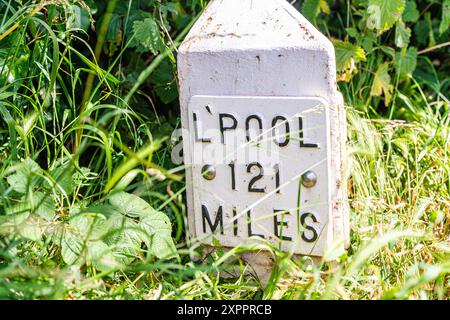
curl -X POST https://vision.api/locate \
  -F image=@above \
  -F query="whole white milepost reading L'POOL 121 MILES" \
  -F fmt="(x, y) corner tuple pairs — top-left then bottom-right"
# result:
(178, 0), (349, 266)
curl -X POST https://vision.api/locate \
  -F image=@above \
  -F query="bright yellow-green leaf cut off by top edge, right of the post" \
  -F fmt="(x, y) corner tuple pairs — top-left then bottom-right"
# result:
(367, 0), (405, 33)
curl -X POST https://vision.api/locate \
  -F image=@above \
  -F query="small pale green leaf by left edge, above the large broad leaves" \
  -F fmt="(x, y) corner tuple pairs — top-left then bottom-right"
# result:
(6, 158), (42, 194)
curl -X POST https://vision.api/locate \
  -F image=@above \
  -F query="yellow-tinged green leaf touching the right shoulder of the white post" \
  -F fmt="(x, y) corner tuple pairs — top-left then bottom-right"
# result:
(333, 40), (366, 82)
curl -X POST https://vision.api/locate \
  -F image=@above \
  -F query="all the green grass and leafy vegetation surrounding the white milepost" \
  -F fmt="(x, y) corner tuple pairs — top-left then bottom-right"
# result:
(0, 0), (450, 299)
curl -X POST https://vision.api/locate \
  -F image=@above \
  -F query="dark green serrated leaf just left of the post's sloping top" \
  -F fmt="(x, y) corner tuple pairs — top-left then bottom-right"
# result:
(133, 18), (163, 55)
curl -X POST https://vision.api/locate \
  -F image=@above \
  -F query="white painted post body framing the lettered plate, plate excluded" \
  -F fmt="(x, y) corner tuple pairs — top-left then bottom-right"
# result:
(178, 0), (349, 268)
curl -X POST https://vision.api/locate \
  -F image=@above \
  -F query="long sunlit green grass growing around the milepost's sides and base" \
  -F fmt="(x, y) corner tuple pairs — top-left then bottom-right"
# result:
(0, 0), (450, 299)
